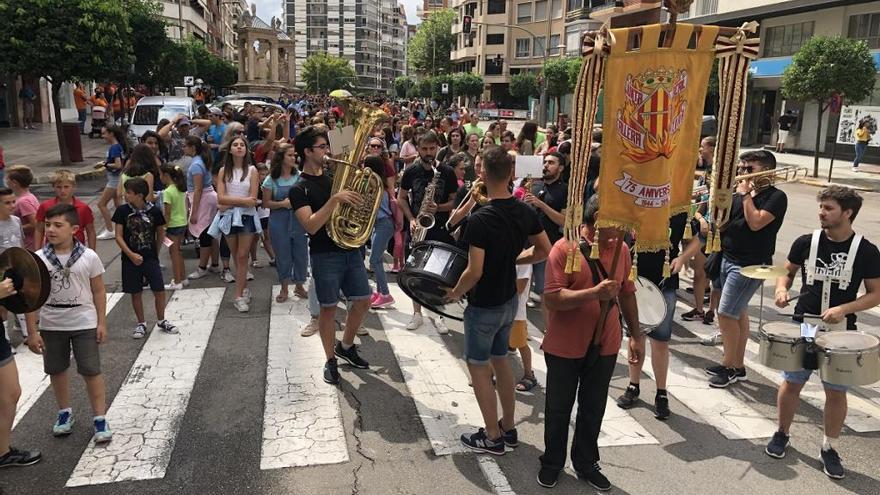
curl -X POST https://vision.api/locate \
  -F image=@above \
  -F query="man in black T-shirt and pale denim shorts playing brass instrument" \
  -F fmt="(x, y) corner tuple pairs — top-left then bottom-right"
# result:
(706, 150), (788, 388)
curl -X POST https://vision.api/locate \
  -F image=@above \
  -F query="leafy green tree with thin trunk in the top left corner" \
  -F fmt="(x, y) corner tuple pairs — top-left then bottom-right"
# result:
(0, 0), (134, 166)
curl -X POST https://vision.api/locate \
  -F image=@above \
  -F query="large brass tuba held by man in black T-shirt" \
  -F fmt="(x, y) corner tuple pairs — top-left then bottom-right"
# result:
(324, 98), (390, 249)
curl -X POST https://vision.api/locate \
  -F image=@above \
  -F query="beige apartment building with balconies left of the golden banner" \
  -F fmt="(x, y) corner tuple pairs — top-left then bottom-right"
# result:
(450, 0), (566, 109)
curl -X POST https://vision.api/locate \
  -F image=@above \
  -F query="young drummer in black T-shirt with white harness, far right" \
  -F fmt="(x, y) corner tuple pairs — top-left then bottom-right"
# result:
(764, 186), (880, 479)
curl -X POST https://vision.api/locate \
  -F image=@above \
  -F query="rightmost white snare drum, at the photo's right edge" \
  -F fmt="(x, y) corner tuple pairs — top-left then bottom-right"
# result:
(816, 331), (880, 386)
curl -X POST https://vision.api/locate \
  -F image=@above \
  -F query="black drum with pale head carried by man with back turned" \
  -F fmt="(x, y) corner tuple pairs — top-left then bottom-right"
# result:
(397, 241), (467, 321)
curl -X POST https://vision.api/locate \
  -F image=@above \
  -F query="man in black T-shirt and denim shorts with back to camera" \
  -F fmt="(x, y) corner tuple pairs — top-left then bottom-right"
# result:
(447, 146), (550, 455)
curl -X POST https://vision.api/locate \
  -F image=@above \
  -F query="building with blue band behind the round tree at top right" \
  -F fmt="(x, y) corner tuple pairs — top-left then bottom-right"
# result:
(688, 0), (880, 154)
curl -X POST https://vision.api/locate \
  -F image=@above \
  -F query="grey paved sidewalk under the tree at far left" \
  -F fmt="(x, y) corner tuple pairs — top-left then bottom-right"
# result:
(0, 122), (108, 184)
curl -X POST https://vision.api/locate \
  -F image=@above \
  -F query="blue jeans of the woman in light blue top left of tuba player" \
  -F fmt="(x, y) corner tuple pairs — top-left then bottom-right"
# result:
(269, 210), (309, 284)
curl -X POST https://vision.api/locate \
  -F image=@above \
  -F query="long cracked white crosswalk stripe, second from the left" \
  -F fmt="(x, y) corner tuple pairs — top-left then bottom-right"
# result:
(67, 288), (225, 487)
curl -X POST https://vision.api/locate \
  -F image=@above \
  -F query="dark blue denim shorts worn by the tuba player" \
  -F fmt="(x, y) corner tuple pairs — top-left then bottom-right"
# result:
(311, 249), (372, 307)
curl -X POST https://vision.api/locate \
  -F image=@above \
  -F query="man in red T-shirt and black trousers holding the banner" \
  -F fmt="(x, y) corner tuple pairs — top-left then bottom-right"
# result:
(538, 195), (639, 490)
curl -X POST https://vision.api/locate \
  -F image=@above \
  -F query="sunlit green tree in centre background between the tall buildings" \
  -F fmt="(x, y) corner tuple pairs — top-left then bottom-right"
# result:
(406, 9), (455, 76)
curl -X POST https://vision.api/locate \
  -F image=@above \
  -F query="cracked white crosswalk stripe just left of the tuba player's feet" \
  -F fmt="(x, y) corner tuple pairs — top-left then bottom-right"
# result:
(260, 286), (348, 469)
